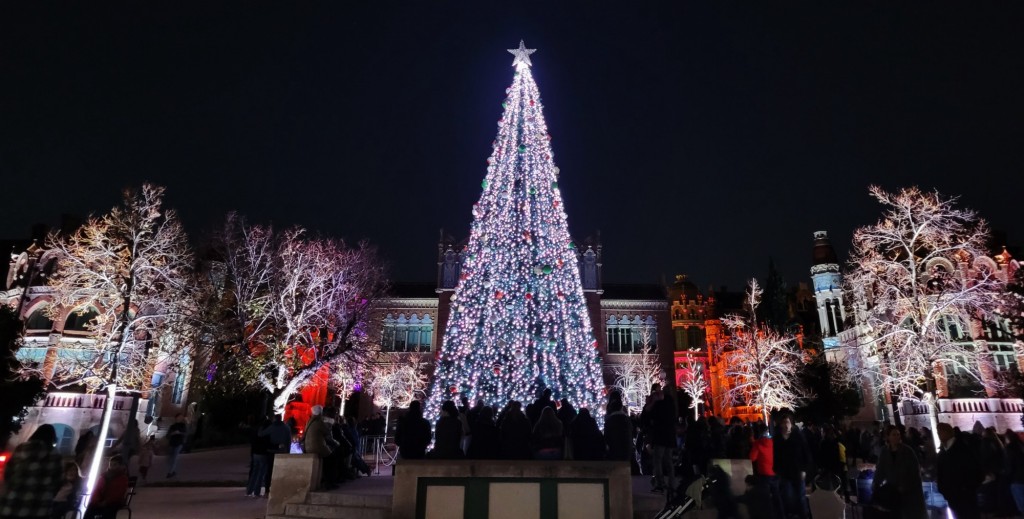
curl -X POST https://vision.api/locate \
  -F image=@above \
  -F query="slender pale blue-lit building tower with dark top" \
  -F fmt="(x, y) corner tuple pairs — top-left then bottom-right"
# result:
(811, 230), (846, 350)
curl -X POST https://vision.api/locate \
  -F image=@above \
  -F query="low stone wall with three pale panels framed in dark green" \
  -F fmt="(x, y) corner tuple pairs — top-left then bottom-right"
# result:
(391, 460), (633, 519)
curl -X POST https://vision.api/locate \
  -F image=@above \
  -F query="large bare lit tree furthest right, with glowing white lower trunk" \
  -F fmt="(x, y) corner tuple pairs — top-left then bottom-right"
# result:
(847, 186), (1001, 445)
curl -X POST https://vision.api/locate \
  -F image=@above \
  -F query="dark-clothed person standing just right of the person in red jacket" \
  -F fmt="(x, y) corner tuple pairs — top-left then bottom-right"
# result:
(772, 415), (811, 519)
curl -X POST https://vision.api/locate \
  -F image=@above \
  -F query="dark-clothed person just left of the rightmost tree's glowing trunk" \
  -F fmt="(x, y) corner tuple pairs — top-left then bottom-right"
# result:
(871, 425), (928, 519)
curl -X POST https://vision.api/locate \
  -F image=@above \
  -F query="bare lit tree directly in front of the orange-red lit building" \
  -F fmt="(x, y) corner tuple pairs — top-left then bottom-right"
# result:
(716, 279), (806, 423)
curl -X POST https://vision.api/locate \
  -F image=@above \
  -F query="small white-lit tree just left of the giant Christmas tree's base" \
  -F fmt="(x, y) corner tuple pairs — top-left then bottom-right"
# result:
(369, 353), (429, 436)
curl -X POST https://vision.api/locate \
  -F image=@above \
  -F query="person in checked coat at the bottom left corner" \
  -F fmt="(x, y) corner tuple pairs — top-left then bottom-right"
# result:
(0, 424), (63, 519)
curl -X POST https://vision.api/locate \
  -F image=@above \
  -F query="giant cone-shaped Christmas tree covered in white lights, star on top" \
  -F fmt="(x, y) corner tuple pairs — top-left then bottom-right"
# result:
(427, 42), (604, 417)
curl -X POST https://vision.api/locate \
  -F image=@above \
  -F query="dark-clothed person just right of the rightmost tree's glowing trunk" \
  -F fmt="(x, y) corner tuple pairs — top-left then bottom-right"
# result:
(935, 423), (983, 519)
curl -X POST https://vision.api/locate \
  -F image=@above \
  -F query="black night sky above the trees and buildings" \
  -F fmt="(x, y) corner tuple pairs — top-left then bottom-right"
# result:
(0, 1), (1024, 288)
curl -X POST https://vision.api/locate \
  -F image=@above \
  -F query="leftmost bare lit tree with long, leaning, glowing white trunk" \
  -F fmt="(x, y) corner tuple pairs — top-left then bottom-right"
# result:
(41, 184), (196, 515)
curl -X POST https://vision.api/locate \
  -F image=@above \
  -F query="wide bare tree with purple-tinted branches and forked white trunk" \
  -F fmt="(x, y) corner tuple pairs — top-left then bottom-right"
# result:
(219, 215), (385, 414)
